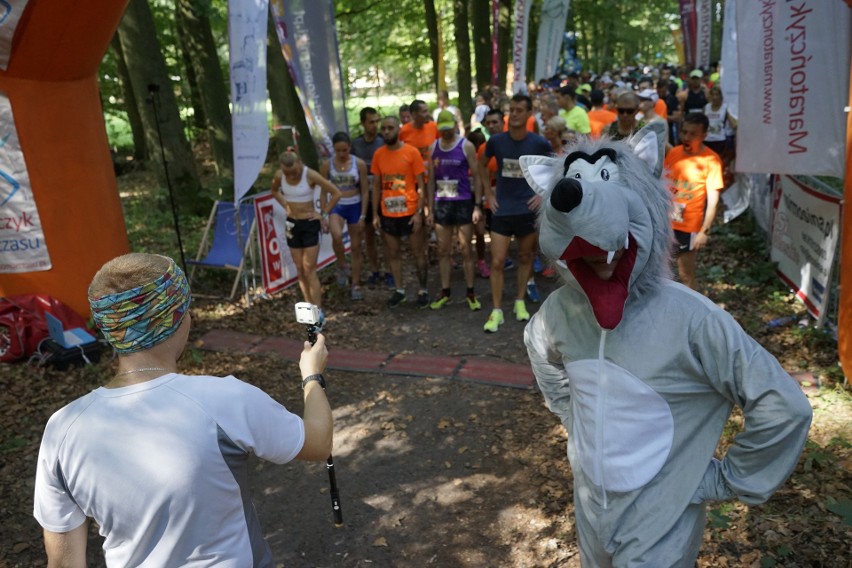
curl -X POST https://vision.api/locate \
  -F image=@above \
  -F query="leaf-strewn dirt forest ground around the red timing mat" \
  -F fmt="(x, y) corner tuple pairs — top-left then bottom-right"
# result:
(0, 163), (852, 568)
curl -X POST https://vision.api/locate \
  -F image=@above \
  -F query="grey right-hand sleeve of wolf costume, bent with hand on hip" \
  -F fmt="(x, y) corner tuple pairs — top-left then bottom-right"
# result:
(690, 310), (812, 505)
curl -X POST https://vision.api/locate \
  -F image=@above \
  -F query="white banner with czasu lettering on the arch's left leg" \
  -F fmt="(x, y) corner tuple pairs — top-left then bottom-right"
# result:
(0, 92), (52, 274)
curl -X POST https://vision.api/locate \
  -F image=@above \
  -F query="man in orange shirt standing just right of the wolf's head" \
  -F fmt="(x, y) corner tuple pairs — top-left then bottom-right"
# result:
(664, 112), (724, 290)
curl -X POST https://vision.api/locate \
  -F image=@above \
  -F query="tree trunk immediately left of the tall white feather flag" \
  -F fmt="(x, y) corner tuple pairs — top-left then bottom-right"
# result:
(176, 0), (234, 178)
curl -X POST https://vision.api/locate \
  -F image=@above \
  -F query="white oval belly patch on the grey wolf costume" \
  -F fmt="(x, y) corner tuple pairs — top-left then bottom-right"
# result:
(565, 359), (674, 492)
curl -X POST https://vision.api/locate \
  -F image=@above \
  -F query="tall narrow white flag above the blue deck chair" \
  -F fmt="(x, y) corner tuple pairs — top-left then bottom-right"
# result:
(228, 0), (269, 203)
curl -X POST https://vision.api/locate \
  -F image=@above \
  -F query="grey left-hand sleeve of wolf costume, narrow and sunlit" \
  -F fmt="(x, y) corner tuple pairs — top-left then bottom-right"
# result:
(524, 310), (571, 428)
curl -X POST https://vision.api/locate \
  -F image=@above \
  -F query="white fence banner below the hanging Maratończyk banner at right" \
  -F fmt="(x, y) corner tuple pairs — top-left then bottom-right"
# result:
(771, 176), (840, 324)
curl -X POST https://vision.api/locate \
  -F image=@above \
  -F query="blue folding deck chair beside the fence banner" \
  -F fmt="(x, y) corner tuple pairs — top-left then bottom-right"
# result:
(187, 200), (257, 300)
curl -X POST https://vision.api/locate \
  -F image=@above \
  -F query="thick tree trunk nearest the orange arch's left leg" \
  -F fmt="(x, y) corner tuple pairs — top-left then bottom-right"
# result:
(118, 0), (206, 215)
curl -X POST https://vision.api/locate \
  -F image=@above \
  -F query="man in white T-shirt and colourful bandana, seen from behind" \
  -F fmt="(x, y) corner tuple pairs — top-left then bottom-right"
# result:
(33, 253), (333, 567)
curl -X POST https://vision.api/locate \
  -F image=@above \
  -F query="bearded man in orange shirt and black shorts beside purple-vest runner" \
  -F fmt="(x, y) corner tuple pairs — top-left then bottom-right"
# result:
(370, 116), (429, 308)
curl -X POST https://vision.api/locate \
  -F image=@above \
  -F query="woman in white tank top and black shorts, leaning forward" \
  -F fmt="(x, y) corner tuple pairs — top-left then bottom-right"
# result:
(272, 147), (340, 309)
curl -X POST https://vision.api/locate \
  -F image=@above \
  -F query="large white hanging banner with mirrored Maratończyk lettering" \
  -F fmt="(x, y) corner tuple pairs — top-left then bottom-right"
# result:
(736, 0), (852, 178)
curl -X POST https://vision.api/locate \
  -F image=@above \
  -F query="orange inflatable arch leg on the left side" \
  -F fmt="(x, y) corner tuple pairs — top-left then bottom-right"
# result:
(0, 0), (130, 317)
